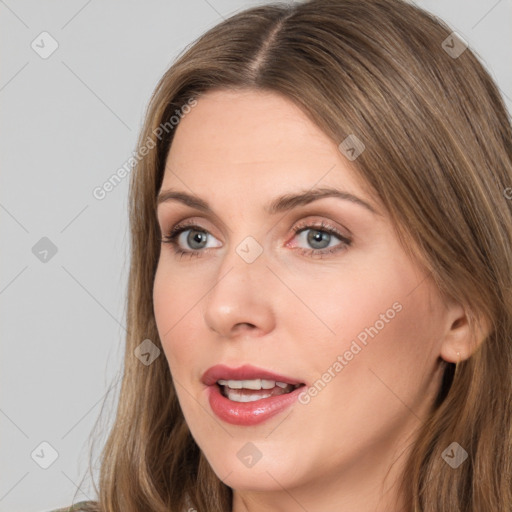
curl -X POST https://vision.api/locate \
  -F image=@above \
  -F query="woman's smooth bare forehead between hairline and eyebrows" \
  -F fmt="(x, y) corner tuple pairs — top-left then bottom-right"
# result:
(163, 90), (366, 194)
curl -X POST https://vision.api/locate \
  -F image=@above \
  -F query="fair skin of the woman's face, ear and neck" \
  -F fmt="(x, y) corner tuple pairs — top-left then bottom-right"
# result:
(154, 90), (476, 512)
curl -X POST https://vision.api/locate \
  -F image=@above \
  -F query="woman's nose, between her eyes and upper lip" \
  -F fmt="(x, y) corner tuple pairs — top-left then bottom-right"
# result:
(204, 240), (275, 338)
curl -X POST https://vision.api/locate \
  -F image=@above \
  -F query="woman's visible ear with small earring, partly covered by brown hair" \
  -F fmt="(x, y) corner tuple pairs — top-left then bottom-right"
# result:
(440, 302), (490, 363)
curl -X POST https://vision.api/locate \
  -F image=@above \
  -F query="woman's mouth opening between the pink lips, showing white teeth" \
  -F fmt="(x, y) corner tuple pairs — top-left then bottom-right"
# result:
(216, 379), (305, 402)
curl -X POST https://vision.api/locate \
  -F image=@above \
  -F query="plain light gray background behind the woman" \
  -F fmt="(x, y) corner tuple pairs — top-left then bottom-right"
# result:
(0, 0), (512, 512)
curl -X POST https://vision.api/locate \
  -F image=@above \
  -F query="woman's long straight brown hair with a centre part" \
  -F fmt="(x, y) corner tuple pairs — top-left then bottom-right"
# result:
(72, 0), (512, 512)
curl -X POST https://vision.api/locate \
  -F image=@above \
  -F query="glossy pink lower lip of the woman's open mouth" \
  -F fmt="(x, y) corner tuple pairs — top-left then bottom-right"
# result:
(208, 384), (304, 426)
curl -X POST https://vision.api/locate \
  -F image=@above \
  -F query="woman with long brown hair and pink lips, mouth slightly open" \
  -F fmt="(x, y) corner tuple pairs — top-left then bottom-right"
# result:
(51, 0), (512, 512)
